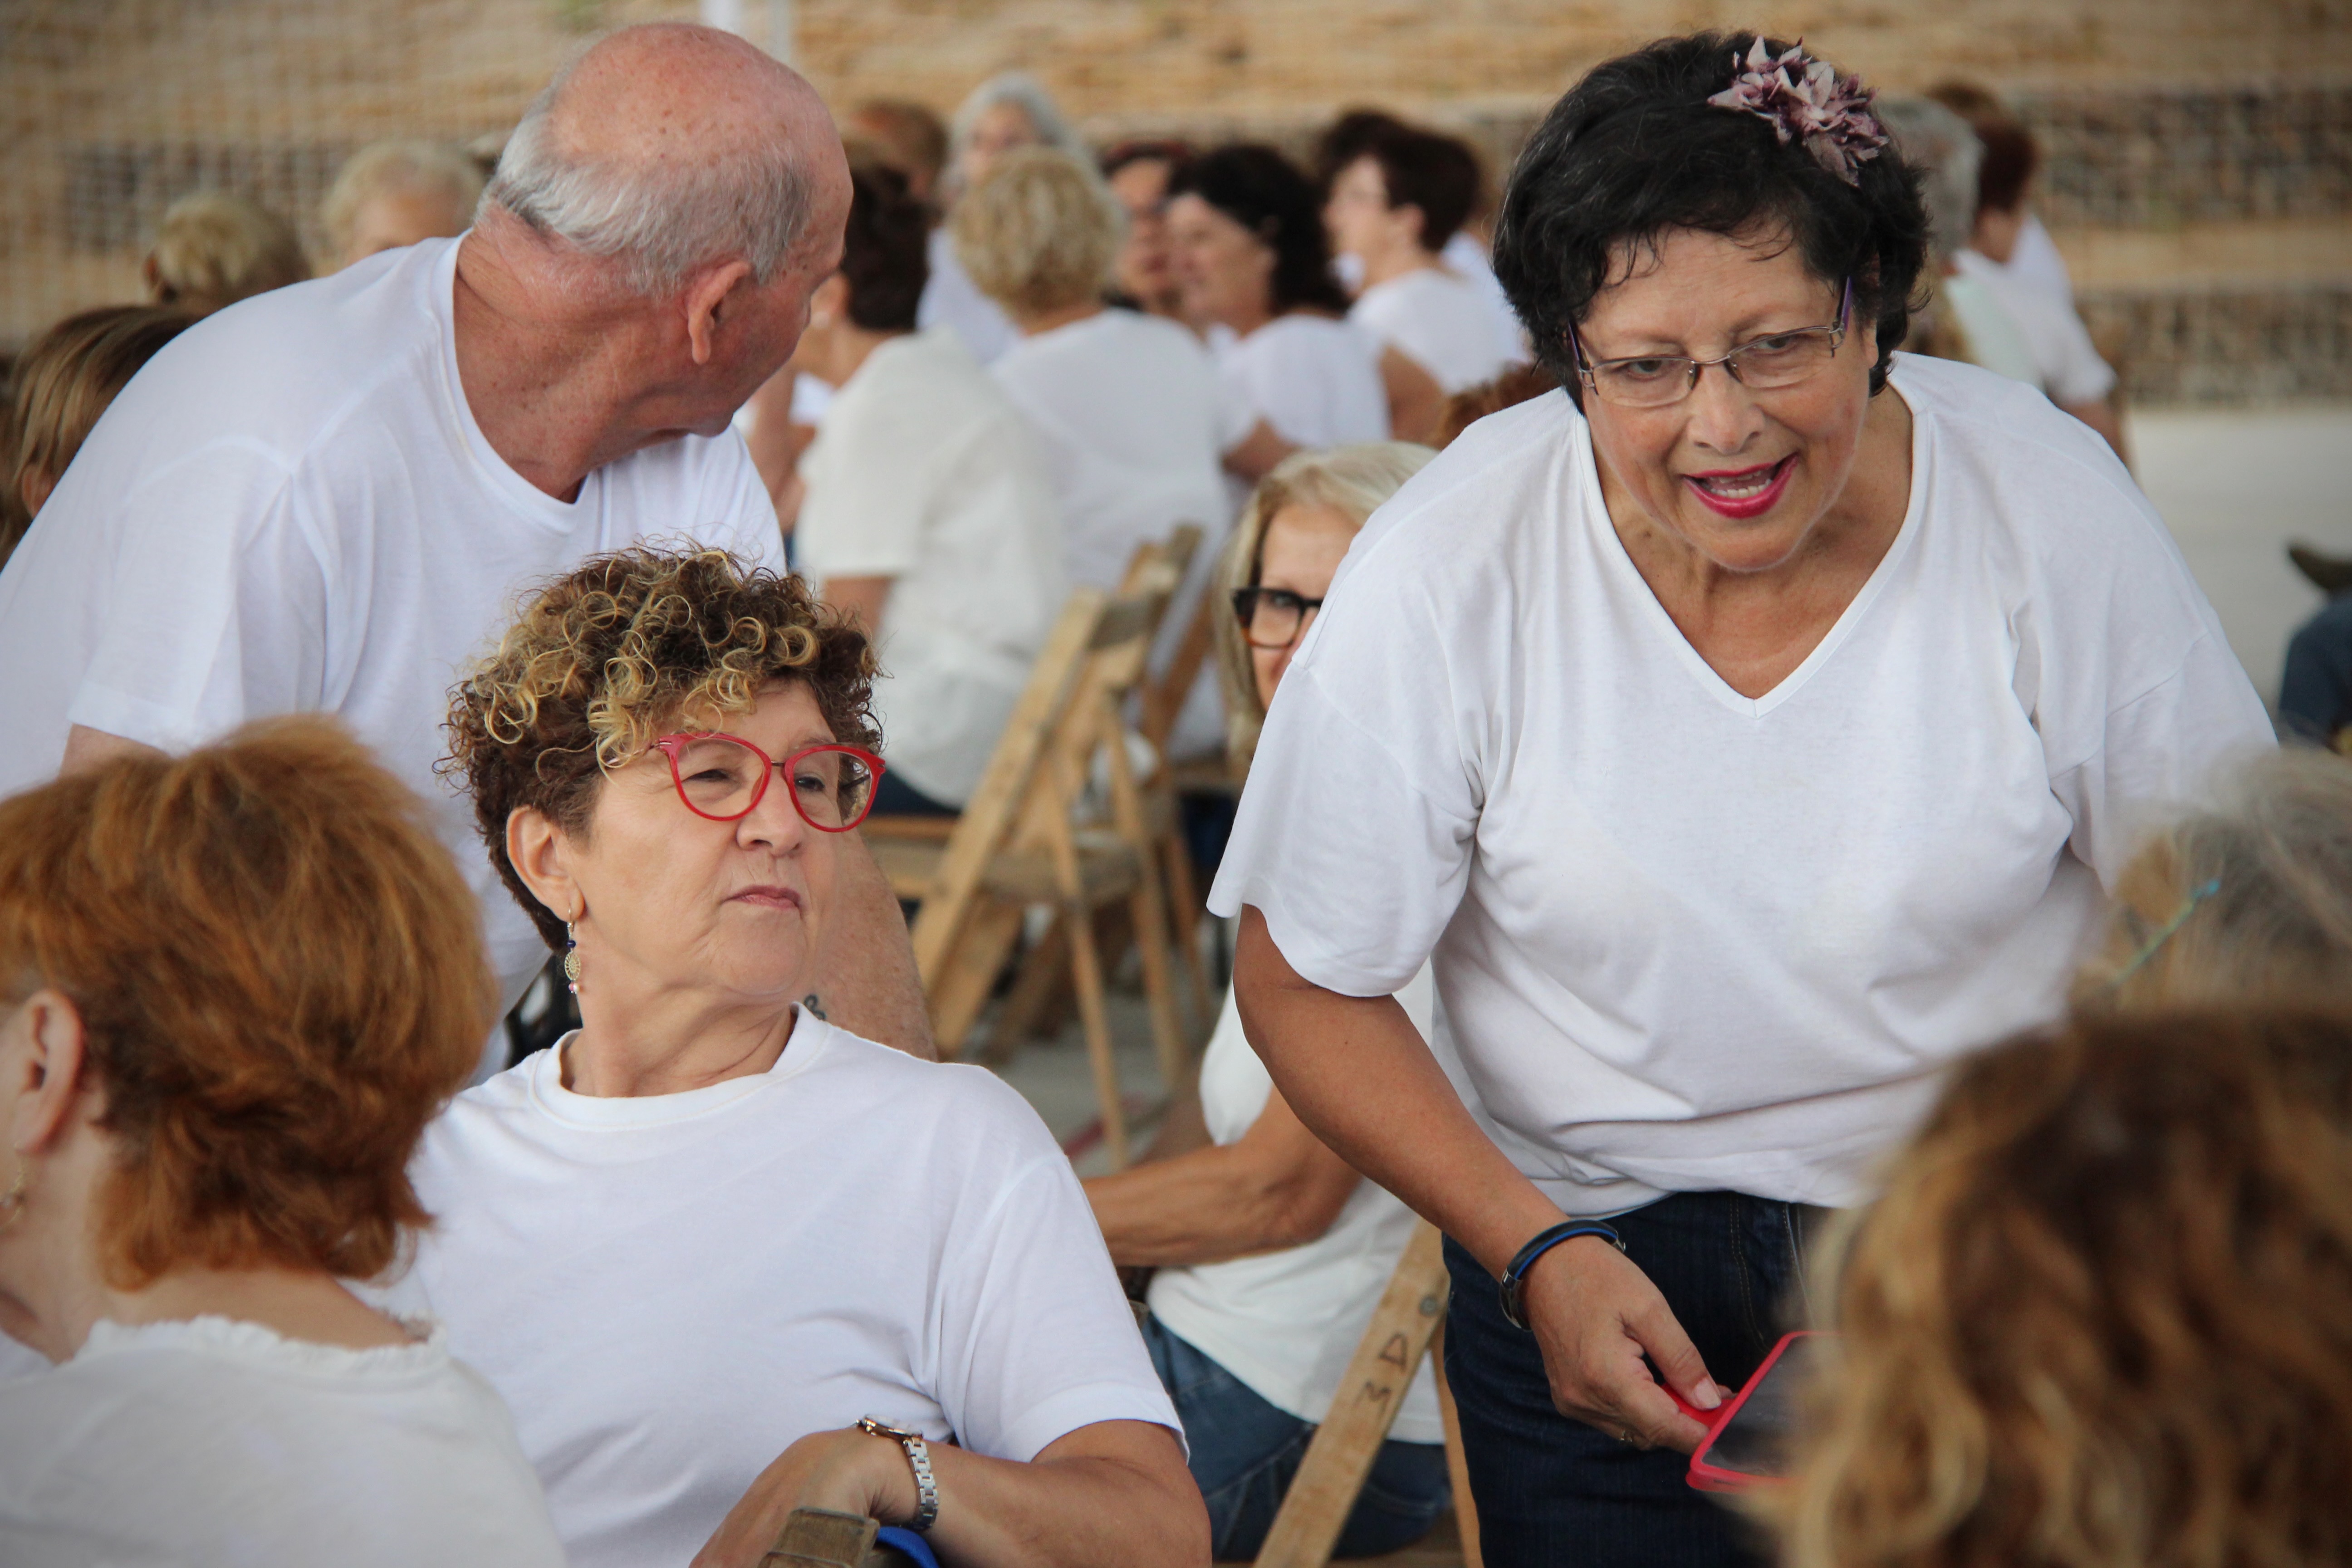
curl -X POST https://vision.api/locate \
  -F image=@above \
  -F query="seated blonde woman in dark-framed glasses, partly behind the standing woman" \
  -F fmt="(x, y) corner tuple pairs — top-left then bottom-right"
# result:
(1087, 442), (1449, 1561)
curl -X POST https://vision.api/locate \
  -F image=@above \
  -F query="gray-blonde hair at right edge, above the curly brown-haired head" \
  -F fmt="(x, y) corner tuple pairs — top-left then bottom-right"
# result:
(2074, 750), (2352, 1011)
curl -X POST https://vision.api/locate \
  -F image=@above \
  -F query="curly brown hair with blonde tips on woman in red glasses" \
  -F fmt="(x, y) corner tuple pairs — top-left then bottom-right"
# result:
(442, 545), (882, 950)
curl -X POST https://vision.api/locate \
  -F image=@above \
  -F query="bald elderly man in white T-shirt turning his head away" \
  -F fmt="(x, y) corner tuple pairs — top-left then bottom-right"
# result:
(0, 26), (931, 1065)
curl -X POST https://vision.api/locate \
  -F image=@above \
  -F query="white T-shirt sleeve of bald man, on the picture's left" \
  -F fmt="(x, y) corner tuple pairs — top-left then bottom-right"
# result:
(68, 442), (332, 750)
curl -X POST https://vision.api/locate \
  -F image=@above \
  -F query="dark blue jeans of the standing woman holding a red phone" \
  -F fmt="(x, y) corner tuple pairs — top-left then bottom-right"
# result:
(1446, 1192), (1820, 1568)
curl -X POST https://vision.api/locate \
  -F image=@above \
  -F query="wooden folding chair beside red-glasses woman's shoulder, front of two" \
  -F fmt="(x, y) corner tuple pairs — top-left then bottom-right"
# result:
(868, 557), (1188, 1168)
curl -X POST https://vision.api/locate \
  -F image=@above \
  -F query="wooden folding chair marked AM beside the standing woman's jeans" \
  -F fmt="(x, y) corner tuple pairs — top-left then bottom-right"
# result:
(1256, 1220), (1480, 1568)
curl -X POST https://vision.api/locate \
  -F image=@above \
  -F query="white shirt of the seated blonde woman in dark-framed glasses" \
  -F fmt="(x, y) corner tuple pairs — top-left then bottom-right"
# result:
(1150, 982), (1446, 1443)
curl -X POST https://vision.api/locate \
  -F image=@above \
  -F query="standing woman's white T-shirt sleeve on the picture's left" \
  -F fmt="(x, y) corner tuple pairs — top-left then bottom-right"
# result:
(1209, 557), (1477, 997)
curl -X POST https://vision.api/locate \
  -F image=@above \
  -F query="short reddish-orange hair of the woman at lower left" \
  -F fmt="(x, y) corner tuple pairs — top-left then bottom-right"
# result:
(0, 717), (496, 1288)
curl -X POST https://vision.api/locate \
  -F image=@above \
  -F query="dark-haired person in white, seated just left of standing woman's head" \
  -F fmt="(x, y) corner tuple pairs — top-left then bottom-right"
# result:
(1324, 129), (1524, 395)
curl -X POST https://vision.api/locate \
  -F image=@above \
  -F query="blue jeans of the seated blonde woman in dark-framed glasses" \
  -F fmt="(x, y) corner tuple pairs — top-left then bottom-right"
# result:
(1143, 1319), (1449, 1568)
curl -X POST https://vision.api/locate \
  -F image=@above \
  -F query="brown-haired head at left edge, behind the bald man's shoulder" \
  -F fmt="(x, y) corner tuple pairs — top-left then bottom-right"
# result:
(0, 306), (195, 567)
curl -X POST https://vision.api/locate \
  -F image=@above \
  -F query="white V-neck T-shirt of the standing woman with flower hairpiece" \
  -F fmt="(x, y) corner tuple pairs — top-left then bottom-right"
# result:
(1209, 355), (2274, 1215)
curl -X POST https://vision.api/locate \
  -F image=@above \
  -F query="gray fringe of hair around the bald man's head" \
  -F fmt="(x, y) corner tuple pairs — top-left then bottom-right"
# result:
(482, 54), (816, 299)
